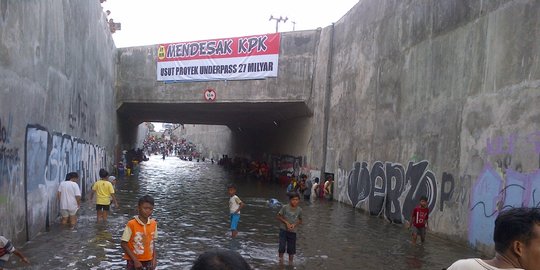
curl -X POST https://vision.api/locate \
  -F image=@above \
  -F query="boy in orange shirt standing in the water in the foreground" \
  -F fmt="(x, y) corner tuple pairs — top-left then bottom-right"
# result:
(121, 195), (157, 270)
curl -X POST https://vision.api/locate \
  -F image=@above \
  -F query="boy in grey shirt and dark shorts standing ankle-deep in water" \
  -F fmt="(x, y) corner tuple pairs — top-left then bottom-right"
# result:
(277, 192), (302, 264)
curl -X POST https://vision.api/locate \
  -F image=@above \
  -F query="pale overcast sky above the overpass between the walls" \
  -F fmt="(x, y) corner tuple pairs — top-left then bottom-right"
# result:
(102, 0), (358, 48)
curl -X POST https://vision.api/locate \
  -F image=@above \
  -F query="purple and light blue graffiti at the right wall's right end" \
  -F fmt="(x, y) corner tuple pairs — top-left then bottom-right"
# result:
(468, 132), (540, 246)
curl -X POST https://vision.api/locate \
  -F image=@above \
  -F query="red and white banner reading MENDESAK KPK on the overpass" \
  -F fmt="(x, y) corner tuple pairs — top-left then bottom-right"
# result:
(157, 34), (280, 82)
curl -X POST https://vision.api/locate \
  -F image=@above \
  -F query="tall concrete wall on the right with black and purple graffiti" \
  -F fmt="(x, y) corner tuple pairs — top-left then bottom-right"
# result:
(320, 0), (540, 253)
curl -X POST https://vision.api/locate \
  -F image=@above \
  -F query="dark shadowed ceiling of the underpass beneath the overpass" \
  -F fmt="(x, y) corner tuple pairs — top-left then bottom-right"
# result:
(118, 102), (312, 129)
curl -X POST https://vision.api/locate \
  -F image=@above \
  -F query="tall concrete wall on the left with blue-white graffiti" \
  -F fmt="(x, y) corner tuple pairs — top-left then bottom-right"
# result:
(0, 0), (116, 243)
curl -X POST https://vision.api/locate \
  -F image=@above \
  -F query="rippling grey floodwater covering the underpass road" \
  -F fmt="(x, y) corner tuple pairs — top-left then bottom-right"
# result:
(6, 156), (479, 270)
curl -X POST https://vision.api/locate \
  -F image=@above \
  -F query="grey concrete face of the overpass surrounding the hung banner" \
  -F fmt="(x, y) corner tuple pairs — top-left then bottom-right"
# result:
(117, 31), (318, 106)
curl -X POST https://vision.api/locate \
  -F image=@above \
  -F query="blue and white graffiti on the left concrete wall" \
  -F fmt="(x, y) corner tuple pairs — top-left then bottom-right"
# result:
(25, 125), (107, 239)
